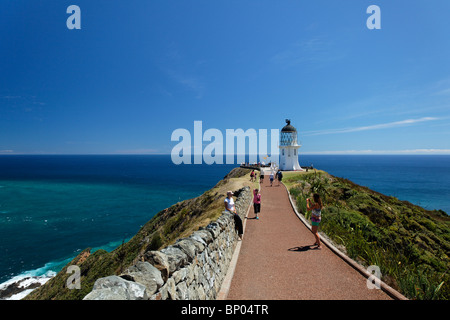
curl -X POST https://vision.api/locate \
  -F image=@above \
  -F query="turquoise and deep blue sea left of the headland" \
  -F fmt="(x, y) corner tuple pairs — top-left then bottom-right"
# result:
(0, 156), (234, 283)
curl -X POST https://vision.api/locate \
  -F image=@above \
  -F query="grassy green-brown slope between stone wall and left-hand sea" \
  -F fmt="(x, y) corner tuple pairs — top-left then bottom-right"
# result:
(25, 168), (255, 300)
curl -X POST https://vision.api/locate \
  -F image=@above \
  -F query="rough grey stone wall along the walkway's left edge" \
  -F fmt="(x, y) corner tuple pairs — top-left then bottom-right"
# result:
(83, 187), (252, 300)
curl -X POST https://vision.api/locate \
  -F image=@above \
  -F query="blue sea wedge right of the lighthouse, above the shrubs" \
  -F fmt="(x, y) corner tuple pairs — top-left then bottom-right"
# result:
(299, 155), (450, 214)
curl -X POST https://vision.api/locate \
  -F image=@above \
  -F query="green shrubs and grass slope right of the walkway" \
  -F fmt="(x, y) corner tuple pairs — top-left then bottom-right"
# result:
(284, 171), (450, 300)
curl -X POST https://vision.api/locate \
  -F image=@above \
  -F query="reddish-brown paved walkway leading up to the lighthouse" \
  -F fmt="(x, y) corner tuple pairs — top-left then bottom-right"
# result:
(227, 176), (391, 300)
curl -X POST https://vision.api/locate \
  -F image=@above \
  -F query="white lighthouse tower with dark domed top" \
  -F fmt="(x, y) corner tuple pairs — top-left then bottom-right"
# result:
(279, 119), (303, 171)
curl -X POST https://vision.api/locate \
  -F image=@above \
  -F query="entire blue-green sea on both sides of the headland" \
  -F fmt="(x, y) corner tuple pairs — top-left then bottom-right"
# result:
(0, 155), (450, 289)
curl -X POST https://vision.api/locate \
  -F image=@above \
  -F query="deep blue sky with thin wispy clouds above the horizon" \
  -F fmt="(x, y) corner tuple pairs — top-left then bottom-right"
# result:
(0, 0), (450, 154)
